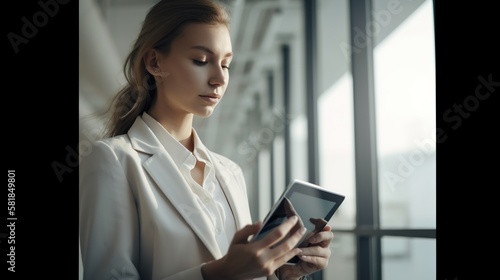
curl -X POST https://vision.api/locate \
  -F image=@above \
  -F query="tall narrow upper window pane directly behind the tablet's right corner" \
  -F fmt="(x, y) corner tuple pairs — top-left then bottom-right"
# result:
(317, 0), (356, 228)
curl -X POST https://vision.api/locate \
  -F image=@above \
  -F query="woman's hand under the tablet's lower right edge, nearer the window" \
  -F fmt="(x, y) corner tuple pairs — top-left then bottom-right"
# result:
(279, 225), (333, 280)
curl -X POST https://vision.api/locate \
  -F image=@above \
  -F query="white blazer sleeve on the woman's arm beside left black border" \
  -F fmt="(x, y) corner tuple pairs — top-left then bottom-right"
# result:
(79, 142), (139, 280)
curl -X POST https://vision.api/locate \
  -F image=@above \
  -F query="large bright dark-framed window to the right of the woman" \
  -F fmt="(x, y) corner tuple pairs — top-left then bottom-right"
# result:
(316, 0), (436, 280)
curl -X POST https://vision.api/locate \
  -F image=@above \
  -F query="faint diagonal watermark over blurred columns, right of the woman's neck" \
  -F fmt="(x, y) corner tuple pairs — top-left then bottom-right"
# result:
(237, 109), (290, 162)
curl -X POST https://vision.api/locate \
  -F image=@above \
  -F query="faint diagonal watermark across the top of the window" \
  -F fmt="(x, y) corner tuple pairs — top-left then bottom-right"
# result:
(339, 0), (403, 59)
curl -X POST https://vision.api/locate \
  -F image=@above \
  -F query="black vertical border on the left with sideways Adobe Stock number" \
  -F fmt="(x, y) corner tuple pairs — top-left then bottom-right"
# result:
(0, 0), (79, 279)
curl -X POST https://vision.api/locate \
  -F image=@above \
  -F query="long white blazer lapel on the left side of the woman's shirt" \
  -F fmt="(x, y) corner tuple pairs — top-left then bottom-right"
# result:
(129, 117), (222, 259)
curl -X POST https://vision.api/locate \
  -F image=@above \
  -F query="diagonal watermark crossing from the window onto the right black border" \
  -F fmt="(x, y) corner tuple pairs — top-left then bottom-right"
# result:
(382, 73), (500, 190)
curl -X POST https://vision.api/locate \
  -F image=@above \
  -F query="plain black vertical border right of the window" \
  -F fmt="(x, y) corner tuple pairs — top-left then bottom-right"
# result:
(436, 0), (500, 280)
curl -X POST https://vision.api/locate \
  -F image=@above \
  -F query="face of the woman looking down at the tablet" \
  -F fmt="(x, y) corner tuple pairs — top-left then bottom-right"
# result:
(153, 23), (232, 117)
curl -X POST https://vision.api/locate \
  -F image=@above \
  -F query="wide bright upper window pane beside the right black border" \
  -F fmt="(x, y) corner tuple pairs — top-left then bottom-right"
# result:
(373, 0), (436, 228)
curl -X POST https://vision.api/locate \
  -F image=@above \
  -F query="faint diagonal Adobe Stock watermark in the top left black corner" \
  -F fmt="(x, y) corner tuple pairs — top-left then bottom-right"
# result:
(7, 0), (70, 54)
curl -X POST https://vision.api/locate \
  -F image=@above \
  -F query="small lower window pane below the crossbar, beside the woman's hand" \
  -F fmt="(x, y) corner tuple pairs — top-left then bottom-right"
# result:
(323, 230), (358, 280)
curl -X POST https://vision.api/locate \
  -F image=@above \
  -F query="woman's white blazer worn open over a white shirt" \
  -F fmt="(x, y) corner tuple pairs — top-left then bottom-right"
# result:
(79, 117), (276, 280)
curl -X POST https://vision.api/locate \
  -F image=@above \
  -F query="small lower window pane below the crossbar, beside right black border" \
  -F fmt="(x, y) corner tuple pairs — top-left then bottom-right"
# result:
(382, 237), (436, 280)
